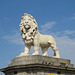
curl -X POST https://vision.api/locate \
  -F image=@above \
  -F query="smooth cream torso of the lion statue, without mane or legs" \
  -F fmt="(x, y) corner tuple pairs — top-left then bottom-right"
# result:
(33, 33), (56, 47)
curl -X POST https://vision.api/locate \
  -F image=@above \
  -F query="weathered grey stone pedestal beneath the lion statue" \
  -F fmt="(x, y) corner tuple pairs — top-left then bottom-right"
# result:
(0, 55), (75, 75)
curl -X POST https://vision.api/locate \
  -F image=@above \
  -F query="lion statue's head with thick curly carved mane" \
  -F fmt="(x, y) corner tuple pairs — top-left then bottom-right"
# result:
(20, 14), (38, 43)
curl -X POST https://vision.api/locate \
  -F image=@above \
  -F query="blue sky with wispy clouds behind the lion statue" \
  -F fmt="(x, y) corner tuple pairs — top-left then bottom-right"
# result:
(0, 0), (75, 75)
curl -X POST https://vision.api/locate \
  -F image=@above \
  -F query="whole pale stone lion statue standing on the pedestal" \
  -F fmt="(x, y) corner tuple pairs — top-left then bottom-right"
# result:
(19, 13), (60, 58)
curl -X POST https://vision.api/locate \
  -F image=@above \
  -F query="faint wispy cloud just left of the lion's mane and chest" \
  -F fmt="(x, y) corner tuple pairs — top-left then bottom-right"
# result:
(2, 32), (24, 45)
